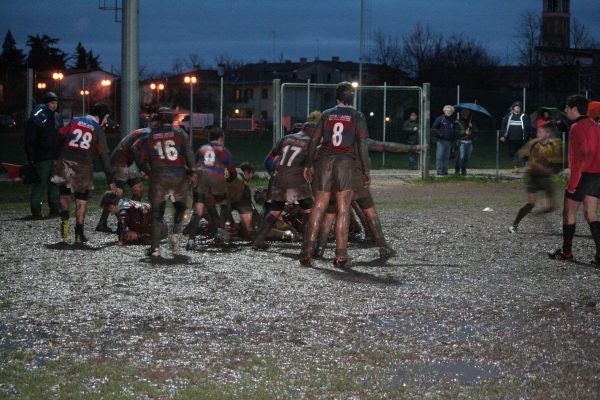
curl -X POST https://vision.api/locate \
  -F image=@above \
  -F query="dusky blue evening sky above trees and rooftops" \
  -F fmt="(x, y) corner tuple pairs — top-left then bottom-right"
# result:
(0, 0), (600, 72)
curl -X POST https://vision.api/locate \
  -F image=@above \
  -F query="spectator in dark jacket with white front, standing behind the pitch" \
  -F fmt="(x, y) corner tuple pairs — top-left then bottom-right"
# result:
(500, 101), (531, 174)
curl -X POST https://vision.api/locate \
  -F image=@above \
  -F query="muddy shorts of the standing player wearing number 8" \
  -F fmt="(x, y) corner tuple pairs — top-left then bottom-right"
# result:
(312, 155), (356, 192)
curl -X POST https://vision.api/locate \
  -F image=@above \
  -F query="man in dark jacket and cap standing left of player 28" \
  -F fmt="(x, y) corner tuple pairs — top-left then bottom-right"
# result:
(25, 92), (61, 219)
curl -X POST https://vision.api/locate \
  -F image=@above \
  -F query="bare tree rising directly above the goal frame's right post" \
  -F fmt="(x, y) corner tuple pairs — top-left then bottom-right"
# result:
(401, 22), (442, 82)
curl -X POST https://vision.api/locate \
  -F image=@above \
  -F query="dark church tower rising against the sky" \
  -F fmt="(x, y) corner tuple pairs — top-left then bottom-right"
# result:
(542, 0), (571, 49)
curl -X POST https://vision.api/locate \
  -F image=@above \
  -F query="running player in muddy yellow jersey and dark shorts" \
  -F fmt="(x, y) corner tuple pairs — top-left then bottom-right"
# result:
(508, 122), (562, 233)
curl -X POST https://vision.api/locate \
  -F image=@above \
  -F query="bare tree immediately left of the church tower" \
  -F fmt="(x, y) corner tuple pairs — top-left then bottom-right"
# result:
(516, 11), (542, 66)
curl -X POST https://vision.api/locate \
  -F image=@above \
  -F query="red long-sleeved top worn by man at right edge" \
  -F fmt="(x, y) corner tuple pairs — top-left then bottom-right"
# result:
(567, 117), (600, 193)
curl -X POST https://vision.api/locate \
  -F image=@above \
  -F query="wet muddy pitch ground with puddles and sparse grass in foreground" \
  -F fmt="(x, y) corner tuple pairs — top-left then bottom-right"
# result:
(0, 178), (600, 399)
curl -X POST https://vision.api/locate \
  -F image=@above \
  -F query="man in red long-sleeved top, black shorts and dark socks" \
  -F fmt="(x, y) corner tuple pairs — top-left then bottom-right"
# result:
(548, 95), (600, 265)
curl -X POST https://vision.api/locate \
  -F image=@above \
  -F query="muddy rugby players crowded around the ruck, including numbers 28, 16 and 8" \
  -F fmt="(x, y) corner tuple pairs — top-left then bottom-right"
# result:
(53, 82), (421, 268)
